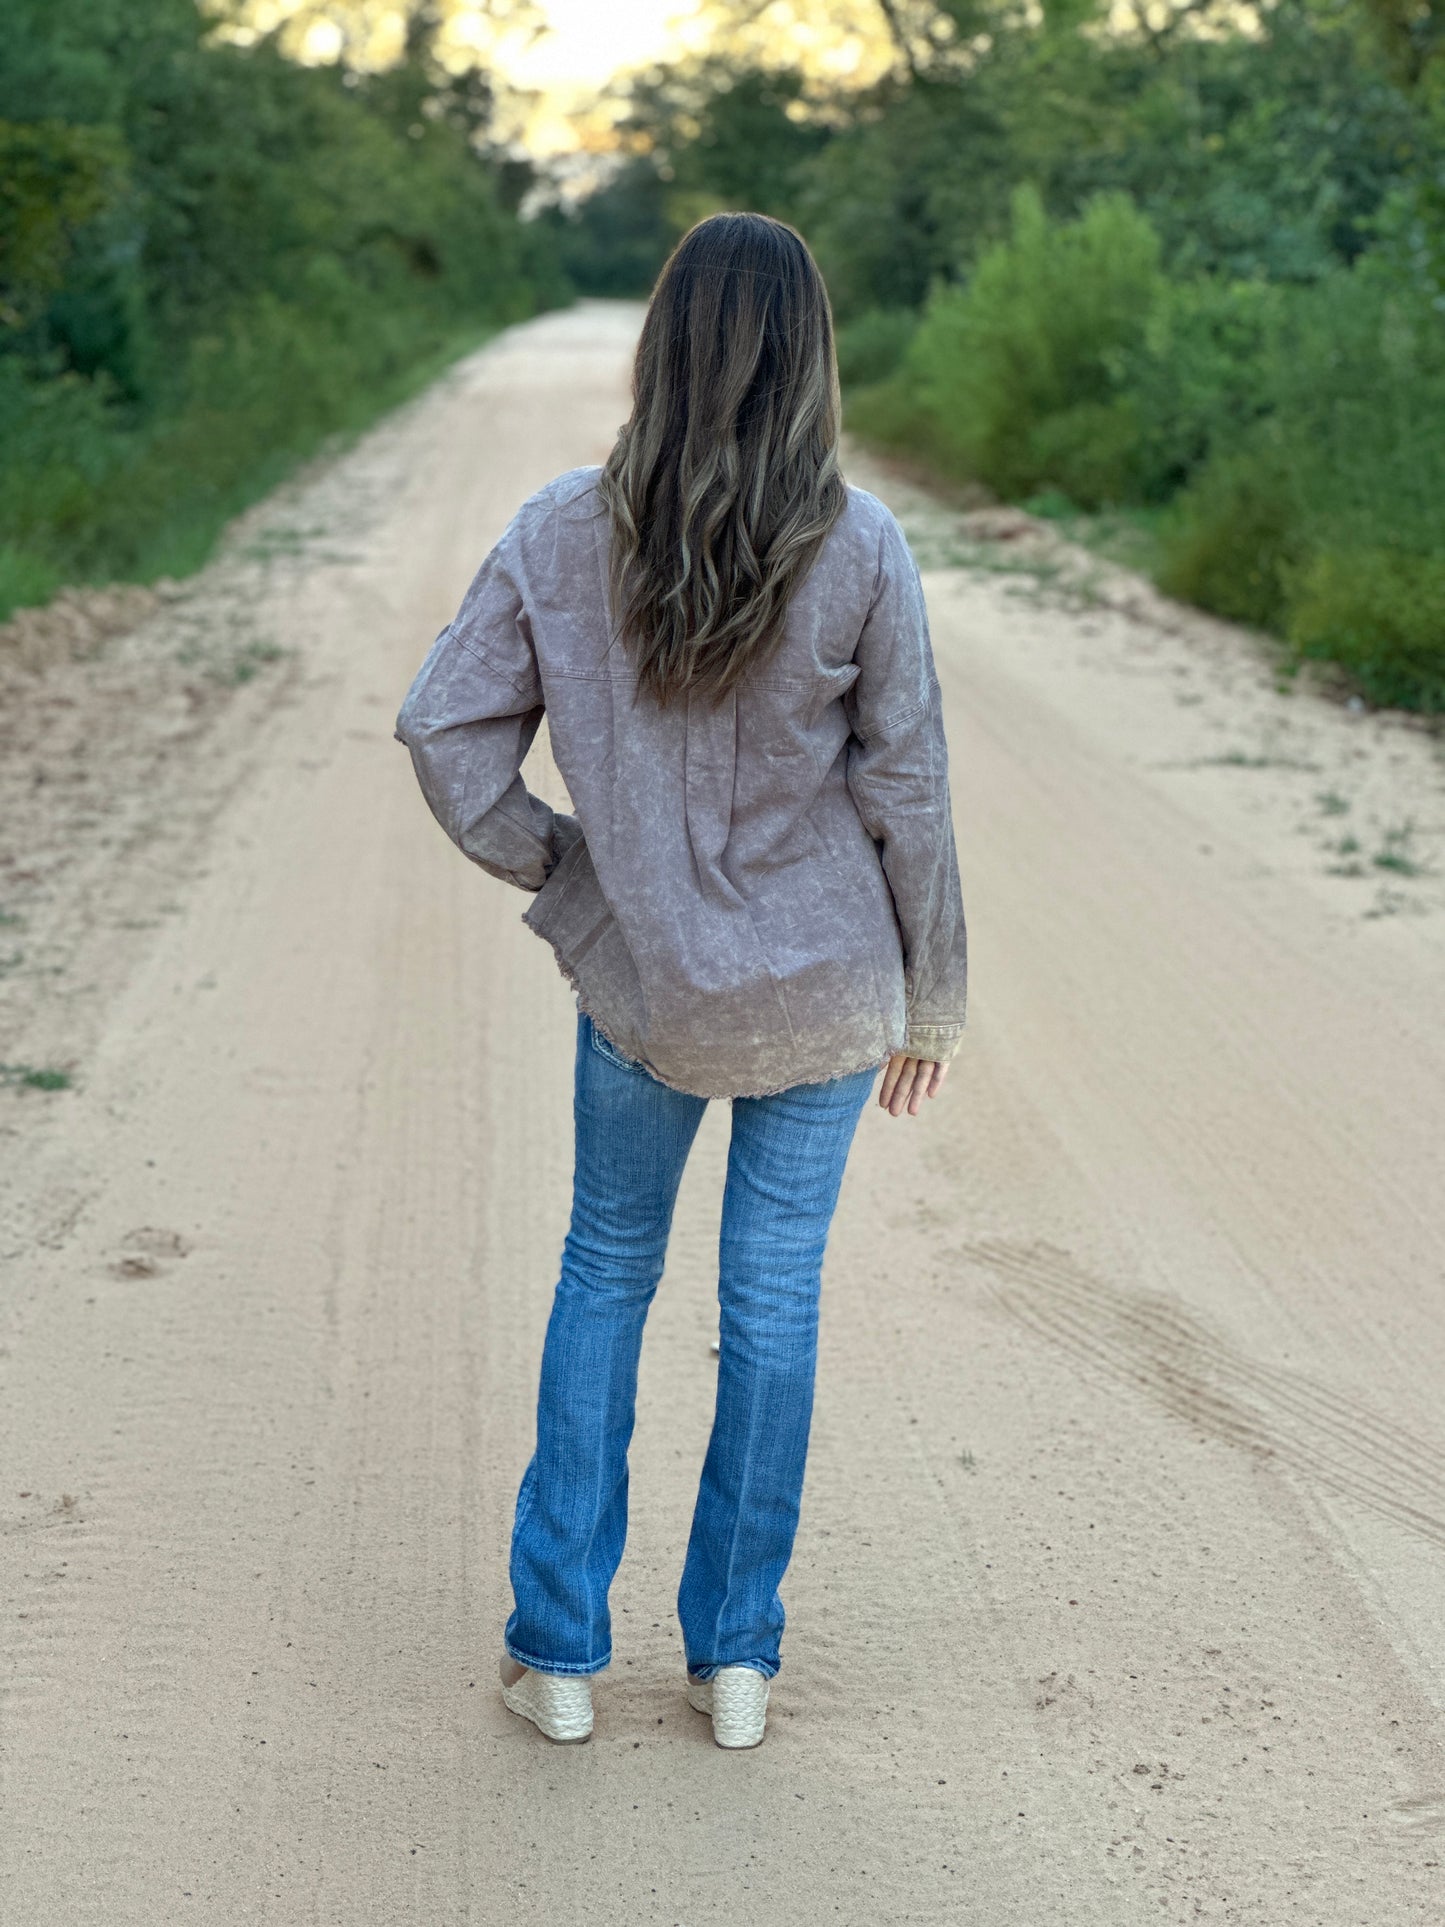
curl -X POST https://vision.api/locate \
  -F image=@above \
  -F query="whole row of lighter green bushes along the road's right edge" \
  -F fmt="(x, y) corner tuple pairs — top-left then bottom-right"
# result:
(842, 181), (1445, 709)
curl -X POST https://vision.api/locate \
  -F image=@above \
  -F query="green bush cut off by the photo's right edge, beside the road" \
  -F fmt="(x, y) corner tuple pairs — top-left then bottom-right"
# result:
(1160, 260), (1445, 709)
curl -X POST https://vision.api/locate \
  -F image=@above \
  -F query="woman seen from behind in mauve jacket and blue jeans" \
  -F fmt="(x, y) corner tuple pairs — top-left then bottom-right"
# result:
(397, 214), (965, 1746)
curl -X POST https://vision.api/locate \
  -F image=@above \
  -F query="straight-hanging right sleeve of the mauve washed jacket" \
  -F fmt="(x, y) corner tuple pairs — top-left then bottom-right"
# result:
(846, 516), (967, 1064)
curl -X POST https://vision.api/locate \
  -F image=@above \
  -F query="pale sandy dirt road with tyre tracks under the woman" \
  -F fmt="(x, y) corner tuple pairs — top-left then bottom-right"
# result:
(0, 306), (1445, 1927)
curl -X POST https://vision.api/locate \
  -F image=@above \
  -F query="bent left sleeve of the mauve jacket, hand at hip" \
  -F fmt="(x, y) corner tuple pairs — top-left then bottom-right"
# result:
(395, 538), (582, 890)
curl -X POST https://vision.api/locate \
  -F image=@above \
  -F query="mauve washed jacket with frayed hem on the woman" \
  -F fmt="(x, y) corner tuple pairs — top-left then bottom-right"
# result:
(397, 468), (967, 1096)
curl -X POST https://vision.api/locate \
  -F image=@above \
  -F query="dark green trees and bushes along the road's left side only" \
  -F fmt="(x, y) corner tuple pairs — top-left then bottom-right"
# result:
(0, 0), (566, 619)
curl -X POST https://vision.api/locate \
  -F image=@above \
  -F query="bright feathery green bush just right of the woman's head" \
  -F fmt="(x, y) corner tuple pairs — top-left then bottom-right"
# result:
(855, 193), (1279, 509)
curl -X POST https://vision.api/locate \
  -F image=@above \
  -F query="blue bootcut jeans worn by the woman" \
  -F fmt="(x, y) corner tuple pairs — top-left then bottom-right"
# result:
(507, 1014), (875, 1678)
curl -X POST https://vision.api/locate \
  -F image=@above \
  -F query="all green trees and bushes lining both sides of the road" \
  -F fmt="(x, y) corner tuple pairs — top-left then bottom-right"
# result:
(0, 0), (1445, 711)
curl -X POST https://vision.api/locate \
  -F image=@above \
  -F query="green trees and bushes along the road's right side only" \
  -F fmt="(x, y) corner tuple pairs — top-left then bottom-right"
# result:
(553, 0), (1445, 711)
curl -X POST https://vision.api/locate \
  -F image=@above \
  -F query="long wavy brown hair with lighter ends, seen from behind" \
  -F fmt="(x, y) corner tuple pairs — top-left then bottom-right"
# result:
(599, 214), (848, 703)
